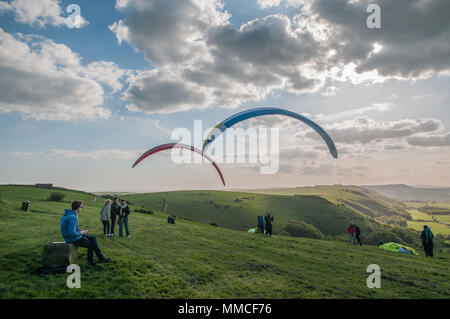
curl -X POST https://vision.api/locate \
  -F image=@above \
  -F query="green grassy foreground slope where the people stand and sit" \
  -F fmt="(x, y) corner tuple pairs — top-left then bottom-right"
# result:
(0, 187), (450, 298)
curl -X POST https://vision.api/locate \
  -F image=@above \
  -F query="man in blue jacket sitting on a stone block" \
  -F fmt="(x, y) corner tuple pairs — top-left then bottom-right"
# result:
(60, 200), (111, 266)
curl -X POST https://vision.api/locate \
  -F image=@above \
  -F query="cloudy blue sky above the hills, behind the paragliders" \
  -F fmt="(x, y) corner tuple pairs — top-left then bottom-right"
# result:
(0, 0), (450, 192)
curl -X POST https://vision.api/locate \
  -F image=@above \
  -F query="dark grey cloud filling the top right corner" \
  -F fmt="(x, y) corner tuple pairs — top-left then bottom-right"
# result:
(303, 0), (450, 78)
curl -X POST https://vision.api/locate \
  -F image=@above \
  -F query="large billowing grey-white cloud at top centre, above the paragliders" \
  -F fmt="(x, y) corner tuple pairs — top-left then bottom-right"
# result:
(110, 0), (322, 113)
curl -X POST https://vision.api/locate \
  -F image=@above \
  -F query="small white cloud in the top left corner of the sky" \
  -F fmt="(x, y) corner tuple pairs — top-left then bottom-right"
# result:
(0, 0), (89, 27)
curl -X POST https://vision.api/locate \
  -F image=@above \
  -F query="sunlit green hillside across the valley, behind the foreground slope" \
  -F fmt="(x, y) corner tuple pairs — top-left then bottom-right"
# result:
(127, 191), (379, 236)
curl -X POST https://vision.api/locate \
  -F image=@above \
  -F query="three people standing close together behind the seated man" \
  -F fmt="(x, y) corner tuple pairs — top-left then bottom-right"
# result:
(100, 197), (130, 238)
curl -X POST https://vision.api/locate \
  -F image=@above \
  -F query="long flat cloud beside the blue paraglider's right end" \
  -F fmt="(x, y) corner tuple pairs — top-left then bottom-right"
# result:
(305, 117), (442, 144)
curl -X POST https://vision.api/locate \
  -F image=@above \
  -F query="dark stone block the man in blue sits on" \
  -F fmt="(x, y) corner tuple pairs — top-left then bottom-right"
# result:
(42, 242), (78, 267)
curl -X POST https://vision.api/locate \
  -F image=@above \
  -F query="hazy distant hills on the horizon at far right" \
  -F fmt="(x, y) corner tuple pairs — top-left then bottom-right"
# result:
(362, 184), (450, 202)
